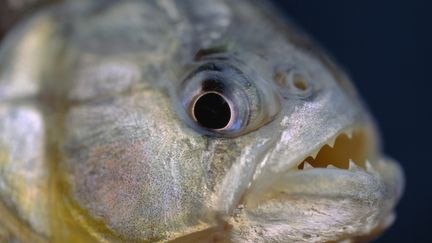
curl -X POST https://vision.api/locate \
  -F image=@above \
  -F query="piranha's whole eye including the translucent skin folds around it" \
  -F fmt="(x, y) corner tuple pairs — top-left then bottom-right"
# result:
(177, 58), (279, 137)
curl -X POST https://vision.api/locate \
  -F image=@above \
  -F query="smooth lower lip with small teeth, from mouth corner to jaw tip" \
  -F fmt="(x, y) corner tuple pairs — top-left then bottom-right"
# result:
(245, 154), (404, 210)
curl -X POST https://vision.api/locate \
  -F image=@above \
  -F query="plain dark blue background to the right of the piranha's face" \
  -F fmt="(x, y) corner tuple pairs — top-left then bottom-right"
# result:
(276, 0), (432, 242)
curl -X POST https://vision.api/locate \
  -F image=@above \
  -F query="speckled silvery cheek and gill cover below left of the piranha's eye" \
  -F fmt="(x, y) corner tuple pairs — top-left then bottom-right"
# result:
(62, 90), (215, 240)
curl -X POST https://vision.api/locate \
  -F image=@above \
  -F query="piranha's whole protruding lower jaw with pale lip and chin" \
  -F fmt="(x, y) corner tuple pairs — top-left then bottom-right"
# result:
(234, 158), (403, 241)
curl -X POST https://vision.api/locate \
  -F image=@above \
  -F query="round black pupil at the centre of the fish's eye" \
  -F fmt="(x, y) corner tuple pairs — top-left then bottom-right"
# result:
(193, 93), (231, 129)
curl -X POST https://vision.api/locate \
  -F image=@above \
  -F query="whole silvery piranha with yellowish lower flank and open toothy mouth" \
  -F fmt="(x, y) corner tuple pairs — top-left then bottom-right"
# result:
(0, 0), (404, 242)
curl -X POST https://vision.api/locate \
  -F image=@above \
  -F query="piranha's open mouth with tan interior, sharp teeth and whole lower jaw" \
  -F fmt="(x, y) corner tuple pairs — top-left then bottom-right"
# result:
(233, 125), (403, 241)
